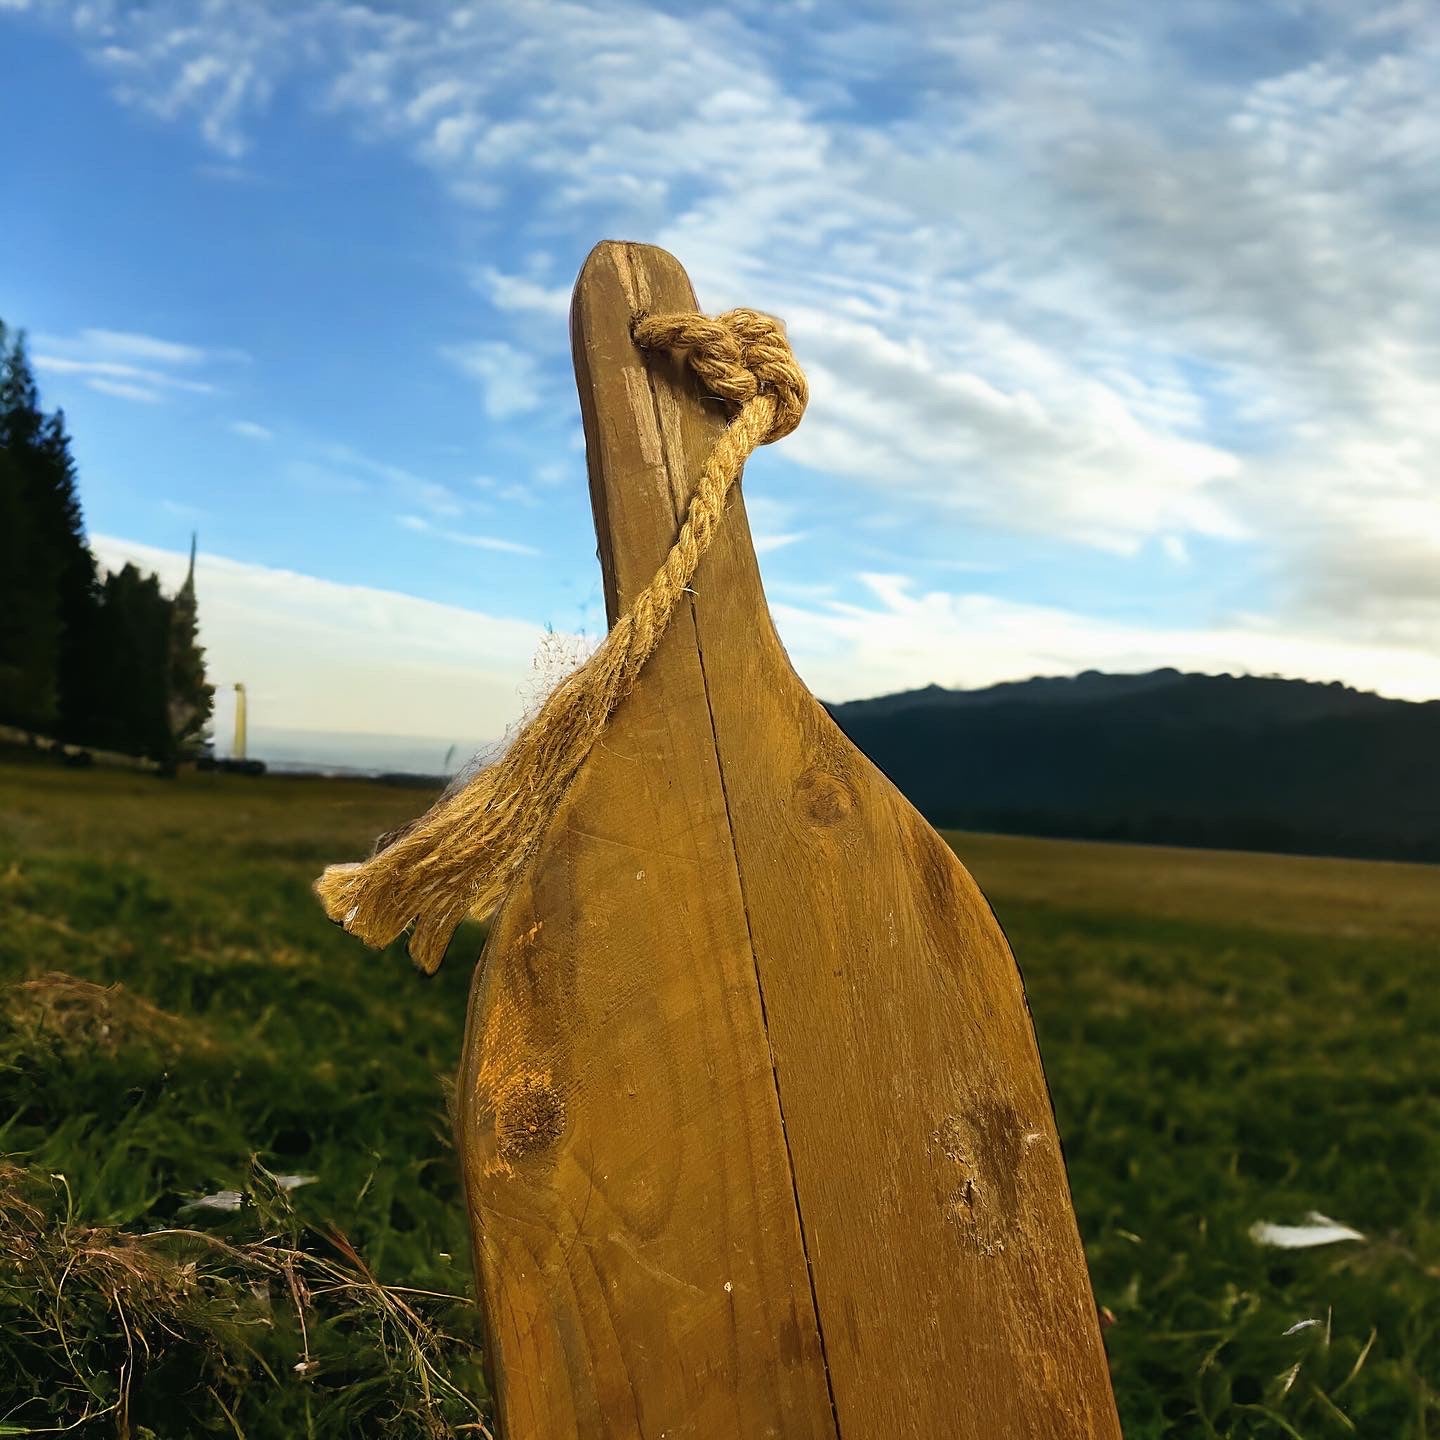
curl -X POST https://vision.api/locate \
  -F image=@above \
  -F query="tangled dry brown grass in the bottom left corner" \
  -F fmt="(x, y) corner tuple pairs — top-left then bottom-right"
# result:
(0, 1162), (490, 1440)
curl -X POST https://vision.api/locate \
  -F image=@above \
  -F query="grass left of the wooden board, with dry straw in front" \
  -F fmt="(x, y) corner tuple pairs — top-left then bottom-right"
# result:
(0, 766), (485, 1440)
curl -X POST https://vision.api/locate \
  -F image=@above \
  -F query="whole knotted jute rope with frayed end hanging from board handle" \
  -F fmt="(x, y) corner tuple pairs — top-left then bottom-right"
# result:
(315, 310), (809, 975)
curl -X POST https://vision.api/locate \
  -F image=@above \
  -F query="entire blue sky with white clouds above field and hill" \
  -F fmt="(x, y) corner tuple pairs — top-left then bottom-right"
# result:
(0, 0), (1440, 777)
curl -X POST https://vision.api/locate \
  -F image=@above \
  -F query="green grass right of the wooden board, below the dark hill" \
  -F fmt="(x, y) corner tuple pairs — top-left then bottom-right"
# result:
(952, 835), (1440, 1440)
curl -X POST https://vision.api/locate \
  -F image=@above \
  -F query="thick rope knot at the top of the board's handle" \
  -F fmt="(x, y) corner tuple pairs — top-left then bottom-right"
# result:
(634, 310), (809, 445)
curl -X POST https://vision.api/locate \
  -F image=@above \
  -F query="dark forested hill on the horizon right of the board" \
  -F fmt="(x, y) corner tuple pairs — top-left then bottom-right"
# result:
(829, 670), (1440, 861)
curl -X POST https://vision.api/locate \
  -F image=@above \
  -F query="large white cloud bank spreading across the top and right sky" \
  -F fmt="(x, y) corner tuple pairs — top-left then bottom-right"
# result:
(28, 0), (1440, 685)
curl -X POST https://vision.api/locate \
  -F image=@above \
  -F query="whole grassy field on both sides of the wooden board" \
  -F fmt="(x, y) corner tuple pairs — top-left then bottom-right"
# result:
(0, 765), (1440, 1440)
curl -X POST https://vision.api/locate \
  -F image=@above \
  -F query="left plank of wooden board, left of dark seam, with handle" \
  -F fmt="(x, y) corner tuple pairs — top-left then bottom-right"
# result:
(458, 239), (835, 1440)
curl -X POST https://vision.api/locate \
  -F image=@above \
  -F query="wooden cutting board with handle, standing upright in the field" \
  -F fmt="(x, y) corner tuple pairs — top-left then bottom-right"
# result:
(458, 243), (1119, 1440)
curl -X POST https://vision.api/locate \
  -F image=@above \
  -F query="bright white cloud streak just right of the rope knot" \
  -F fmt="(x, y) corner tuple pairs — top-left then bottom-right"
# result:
(789, 307), (1246, 553)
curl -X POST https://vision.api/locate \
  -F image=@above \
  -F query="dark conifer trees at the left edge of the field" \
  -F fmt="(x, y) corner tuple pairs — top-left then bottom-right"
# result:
(0, 323), (215, 766)
